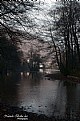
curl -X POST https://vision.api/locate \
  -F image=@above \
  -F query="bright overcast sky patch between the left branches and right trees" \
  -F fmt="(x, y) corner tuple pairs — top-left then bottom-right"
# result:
(11, 0), (56, 40)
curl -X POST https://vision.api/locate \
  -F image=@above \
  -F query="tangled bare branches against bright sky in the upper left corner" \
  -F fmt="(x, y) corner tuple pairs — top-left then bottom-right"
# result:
(0, 0), (34, 30)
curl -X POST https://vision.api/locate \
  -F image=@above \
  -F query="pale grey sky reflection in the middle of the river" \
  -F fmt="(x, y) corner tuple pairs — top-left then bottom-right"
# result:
(18, 73), (58, 115)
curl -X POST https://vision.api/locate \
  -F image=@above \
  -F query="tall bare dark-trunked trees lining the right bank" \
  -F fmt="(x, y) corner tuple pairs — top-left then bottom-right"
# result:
(49, 0), (80, 75)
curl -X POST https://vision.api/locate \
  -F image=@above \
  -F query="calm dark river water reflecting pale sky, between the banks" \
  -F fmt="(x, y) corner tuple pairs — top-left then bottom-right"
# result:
(0, 70), (80, 117)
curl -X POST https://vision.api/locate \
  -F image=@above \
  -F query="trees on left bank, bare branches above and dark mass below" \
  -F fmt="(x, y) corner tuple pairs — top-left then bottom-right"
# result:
(0, 0), (37, 76)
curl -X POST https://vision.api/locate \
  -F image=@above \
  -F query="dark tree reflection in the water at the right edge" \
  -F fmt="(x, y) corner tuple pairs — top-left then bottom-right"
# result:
(66, 82), (80, 118)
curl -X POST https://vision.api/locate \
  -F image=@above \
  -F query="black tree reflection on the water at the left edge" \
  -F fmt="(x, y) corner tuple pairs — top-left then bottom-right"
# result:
(0, 75), (21, 105)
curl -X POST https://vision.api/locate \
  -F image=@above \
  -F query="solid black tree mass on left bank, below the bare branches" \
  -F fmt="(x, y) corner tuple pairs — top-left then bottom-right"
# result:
(0, 33), (21, 75)
